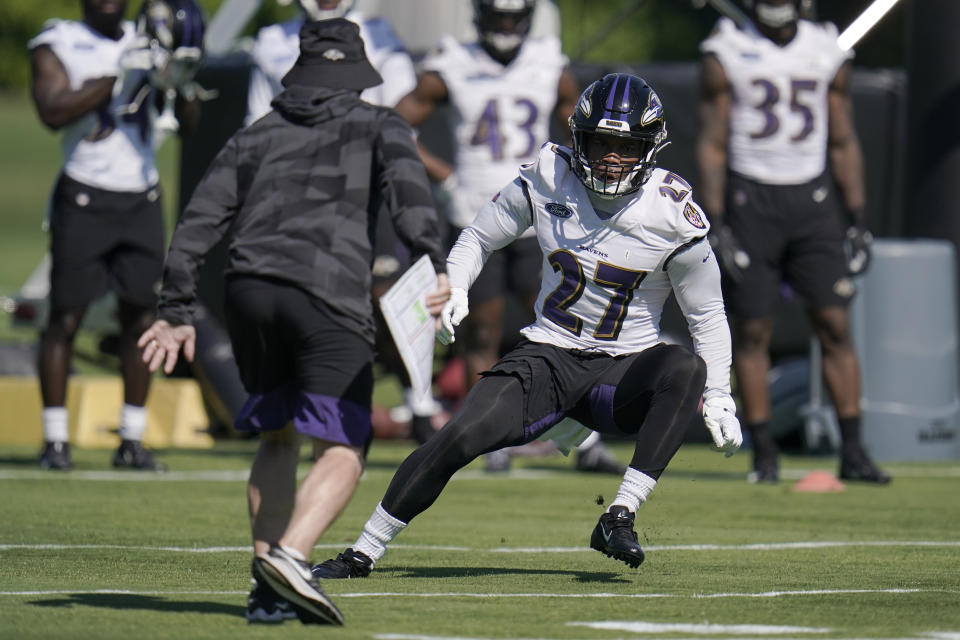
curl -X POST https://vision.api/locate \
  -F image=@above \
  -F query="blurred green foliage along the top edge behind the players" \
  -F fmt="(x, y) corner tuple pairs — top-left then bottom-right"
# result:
(0, 0), (905, 90)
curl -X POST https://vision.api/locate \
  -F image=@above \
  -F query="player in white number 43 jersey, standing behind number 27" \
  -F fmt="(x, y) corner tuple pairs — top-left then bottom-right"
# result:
(396, 0), (623, 474)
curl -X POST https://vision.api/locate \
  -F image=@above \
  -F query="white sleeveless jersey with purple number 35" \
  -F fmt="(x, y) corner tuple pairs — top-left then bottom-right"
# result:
(700, 18), (853, 184)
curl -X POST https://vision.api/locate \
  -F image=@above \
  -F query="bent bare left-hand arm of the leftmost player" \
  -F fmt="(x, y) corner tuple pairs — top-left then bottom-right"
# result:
(30, 46), (116, 130)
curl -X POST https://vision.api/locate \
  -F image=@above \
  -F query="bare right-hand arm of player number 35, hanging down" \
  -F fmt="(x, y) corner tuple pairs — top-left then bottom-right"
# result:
(827, 63), (866, 226)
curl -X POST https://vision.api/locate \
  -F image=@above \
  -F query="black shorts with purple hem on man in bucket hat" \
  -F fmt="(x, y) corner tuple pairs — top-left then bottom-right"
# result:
(224, 276), (373, 447)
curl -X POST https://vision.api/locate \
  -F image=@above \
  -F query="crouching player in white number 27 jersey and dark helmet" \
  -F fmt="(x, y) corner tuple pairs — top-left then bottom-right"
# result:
(314, 73), (741, 578)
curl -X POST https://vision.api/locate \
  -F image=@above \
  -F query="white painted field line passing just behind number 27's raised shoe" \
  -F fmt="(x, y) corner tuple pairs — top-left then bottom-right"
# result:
(0, 540), (960, 553)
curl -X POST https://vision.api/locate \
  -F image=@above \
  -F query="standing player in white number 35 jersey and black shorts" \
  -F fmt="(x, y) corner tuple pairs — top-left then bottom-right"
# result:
(697, 0), (890, 484)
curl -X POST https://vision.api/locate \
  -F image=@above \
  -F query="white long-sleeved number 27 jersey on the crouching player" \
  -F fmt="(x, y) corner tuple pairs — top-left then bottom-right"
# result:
(447, 143), (730, 394)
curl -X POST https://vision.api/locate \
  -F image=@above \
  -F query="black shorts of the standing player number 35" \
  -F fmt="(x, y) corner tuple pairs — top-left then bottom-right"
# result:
(723, 174), (856, 319)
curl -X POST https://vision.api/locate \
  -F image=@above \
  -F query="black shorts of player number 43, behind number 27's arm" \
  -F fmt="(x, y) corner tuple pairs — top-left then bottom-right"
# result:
(451, 229), (543, 305)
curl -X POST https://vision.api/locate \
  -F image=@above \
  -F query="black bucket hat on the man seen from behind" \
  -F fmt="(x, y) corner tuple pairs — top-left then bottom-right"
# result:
(281, 18), (383, 91)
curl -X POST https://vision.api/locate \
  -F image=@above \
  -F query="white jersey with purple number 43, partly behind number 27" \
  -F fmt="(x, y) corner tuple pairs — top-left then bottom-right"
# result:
(422, 36), (568, 227)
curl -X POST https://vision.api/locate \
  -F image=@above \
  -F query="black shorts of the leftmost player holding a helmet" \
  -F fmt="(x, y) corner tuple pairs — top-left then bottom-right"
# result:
(50, 175), (164, 309)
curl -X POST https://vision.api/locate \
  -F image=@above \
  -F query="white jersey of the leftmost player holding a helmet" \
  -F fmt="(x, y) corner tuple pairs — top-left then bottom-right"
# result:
(27, 20), (159, 192)
